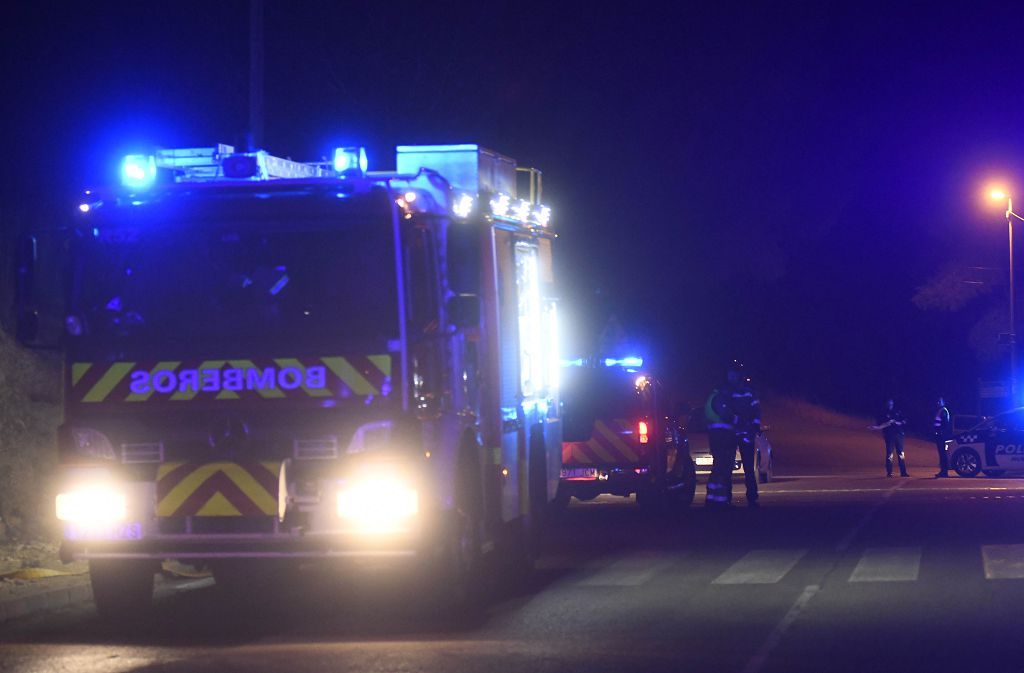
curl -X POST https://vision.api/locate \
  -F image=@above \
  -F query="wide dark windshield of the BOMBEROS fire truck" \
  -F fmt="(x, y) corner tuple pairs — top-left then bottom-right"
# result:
(71, 196), (398, 359)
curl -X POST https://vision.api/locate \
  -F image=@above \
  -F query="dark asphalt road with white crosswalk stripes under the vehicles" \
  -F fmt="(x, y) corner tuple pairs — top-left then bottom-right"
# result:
(0, 470), (1024, 673)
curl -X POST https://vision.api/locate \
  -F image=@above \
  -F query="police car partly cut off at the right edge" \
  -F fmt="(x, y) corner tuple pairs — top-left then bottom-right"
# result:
(946, 407), (1024, 476)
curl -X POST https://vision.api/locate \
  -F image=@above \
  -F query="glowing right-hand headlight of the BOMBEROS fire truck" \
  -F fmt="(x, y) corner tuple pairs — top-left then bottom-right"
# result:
(338, 475), (420, 534)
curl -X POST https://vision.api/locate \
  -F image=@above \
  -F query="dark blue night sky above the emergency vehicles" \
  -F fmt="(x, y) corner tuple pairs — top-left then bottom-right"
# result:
(0, 0), (1024, 428)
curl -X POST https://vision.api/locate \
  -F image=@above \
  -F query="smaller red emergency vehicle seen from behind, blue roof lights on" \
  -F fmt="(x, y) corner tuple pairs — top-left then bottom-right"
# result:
(557, 355), (696, 512)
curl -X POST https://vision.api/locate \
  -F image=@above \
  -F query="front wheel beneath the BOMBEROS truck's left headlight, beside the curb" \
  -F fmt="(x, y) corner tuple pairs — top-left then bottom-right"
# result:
(89, 558), (157, 622)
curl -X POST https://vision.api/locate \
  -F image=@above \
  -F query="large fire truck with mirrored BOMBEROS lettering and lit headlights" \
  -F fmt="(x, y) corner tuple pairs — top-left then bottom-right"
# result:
(18, 144), (561, 617)
